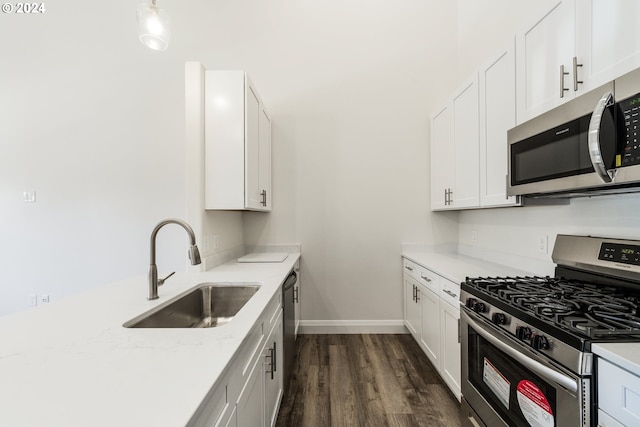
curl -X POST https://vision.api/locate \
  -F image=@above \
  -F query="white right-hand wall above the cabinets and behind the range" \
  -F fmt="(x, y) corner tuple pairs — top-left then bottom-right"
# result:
(458, 0), (640, 274)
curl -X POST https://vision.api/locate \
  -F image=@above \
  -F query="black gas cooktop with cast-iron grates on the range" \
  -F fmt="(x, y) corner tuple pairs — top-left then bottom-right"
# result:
(462, 276), (640, 340)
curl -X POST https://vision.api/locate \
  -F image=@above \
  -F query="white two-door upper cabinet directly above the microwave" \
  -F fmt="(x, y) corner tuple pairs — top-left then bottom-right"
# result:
(516, 0), (640, 123)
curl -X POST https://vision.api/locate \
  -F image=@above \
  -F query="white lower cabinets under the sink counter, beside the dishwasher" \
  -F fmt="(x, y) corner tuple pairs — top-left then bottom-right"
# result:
(187, 292), (283, 427)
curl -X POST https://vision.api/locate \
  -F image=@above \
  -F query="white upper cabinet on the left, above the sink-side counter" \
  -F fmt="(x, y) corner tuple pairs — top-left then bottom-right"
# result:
(205, 70), (271, 211)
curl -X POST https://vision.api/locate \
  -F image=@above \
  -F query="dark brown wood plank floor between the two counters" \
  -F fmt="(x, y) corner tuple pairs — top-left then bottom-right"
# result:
(276, 334), (460, 427)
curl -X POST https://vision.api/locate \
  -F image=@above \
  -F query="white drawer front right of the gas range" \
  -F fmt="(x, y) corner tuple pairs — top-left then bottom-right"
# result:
(598, 359), (640, 426)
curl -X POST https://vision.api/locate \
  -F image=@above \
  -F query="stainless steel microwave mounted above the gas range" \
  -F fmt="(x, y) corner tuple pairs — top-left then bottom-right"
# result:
(507, 69), (640, 197)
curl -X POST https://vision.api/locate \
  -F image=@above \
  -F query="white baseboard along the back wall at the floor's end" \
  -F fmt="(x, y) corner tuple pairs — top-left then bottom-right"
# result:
(300, 320), (409, 334)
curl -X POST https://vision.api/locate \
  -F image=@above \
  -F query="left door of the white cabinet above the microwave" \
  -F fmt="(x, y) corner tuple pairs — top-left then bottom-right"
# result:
(516, 0), (576, 123)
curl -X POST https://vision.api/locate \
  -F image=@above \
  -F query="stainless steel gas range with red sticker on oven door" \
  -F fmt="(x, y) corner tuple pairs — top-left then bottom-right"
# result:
(460, 235), (640, 427)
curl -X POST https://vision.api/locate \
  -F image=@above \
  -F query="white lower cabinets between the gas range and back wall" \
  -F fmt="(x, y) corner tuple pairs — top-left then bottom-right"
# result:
(403, 258), (461, 400)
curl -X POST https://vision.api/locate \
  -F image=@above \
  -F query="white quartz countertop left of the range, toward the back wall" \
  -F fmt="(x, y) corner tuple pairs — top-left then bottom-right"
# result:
(402, 249), (532, 283)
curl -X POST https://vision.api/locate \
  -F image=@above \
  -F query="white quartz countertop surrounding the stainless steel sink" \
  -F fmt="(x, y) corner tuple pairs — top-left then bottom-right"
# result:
(0, 253), (300, 427)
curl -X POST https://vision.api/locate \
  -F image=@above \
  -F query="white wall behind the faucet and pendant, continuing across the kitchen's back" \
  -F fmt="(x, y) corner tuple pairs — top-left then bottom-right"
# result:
(0, 0), (457, 319)
